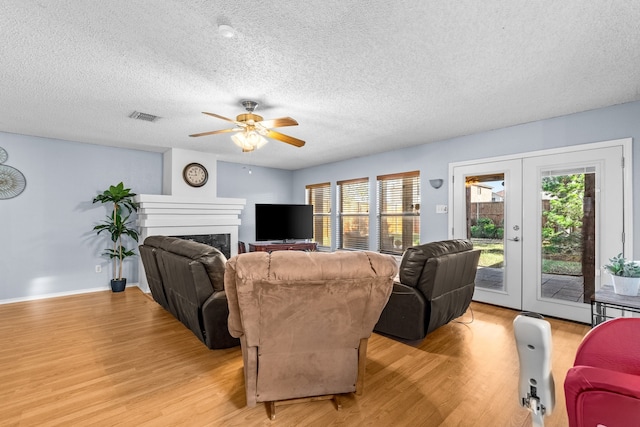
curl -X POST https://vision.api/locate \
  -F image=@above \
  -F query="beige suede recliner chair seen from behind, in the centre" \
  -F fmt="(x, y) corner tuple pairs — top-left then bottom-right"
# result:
(224, 251), (397, 419)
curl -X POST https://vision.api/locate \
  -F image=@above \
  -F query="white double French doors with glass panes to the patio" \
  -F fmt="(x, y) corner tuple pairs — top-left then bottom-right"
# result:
(450, 145), (630, 323)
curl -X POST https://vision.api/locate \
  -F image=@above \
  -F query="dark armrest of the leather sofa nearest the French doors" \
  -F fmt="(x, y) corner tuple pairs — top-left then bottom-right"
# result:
(373, 282), (430, 340)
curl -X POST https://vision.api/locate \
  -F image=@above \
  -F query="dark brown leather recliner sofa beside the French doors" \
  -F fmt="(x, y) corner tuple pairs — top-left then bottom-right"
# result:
(374, 240), (480, 341)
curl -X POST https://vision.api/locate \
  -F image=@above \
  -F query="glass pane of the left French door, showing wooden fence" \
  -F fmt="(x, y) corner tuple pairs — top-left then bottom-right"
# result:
(465, 173), (507, 291)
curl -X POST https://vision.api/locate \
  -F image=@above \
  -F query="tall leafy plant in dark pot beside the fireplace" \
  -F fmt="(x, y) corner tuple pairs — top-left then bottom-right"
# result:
(93, 182), (138, 292)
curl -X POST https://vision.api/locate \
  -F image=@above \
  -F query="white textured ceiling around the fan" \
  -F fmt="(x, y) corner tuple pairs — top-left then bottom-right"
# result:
(0, 0), (640, 169)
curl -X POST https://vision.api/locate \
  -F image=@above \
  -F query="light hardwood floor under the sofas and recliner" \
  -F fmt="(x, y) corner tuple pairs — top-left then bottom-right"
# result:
(0, 288), (589, 427)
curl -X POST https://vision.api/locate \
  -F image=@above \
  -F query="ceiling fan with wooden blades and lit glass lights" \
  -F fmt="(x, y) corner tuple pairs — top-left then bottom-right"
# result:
(189, 101), (305, 152)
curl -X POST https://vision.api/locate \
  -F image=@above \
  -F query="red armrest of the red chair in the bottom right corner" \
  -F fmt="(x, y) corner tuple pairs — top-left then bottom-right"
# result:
(564, 366), (640, 426)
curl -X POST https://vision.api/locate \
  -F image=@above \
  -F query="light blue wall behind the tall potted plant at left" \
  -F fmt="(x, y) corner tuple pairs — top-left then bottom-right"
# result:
(0, 133), (162, 301)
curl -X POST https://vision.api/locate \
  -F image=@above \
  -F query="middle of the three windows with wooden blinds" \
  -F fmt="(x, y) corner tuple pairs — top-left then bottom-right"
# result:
(338, 178), (369, 250)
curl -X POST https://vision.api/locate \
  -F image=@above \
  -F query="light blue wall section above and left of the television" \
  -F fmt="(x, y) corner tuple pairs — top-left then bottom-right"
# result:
(218, 162), (294, 247)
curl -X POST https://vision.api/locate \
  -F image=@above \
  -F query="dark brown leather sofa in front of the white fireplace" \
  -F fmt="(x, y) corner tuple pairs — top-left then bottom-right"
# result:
(140, 236), (240, 349)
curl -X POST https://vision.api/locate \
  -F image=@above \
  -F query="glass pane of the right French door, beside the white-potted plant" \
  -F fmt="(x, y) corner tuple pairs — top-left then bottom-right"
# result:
(540, 168), (596, 303)
